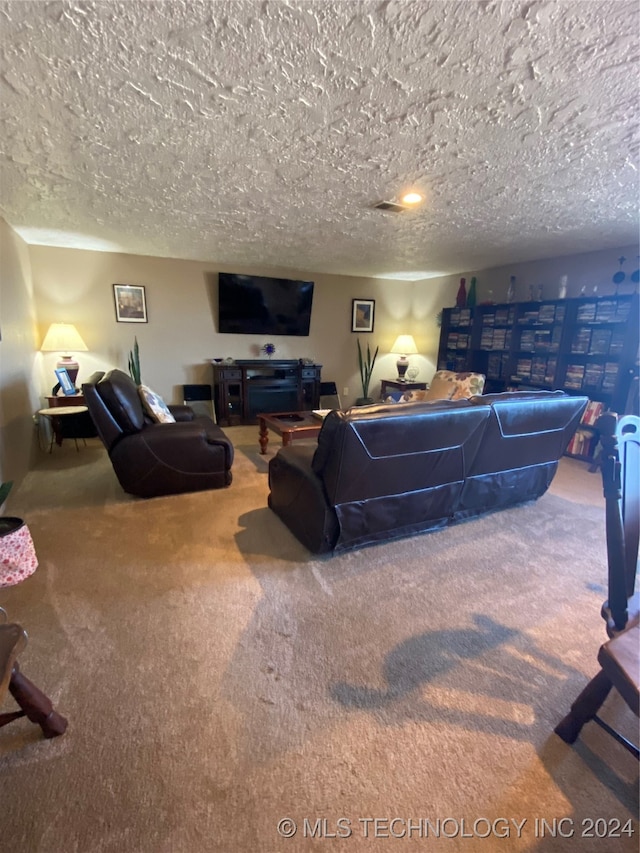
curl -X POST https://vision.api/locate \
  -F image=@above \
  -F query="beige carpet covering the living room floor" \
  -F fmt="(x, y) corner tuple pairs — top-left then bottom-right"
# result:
(0, 427), (638, 853)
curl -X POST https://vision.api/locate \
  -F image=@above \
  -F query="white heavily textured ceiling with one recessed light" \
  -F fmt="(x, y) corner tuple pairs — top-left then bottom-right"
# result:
(0, 0), (640, 277)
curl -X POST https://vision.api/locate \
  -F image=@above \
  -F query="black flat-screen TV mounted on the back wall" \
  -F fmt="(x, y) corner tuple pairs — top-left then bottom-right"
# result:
(218, 272), (313, 335)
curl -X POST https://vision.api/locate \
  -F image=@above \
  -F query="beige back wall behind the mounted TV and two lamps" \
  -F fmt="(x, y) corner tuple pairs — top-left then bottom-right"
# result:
(30, 246), (455, 404)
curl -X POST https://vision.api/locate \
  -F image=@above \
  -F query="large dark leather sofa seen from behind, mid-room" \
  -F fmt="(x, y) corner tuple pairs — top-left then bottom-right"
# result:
(269, 391), (587, 553)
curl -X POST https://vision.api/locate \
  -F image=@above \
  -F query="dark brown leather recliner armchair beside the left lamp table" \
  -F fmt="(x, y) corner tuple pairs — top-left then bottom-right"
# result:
(82, 369), (233, 498)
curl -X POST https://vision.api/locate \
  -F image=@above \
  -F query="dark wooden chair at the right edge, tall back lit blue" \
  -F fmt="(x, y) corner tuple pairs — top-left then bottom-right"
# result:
(555, 413), (640, 759)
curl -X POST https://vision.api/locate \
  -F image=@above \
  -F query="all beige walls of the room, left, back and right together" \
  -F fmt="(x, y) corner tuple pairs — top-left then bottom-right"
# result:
(0, 215), (638, 492)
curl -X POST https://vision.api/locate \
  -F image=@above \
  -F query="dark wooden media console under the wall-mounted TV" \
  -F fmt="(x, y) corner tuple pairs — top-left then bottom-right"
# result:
(213, 358), (322, 426)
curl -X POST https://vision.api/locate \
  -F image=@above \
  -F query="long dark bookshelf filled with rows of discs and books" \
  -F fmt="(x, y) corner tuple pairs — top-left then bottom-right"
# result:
(438, 294), (639, 458)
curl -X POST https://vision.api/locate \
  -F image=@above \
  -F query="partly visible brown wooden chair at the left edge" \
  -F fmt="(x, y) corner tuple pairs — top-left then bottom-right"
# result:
(0, 608), (67, 738)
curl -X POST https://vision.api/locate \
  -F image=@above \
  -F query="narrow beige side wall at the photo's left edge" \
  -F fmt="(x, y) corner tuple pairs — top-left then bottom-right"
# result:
(0, 218), (40, 490)
